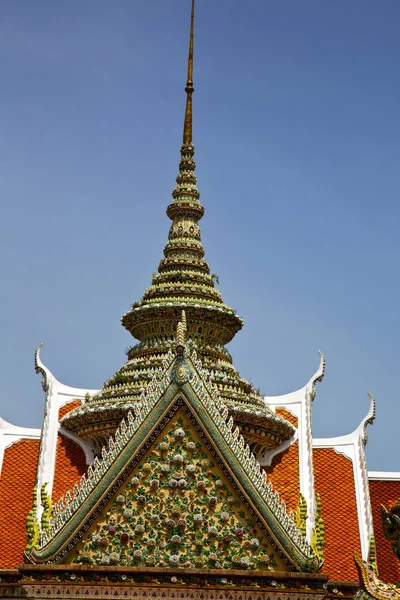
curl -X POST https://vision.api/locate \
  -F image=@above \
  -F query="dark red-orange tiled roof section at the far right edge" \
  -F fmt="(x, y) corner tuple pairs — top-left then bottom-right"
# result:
(369, 481), (400, 583)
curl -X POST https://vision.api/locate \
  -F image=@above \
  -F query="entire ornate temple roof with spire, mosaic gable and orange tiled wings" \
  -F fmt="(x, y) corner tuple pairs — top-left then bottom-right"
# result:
(0, 3), (400, 600)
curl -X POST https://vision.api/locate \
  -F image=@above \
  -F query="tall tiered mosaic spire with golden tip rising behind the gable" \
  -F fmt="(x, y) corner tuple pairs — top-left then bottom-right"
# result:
(63, 0), (293, 454)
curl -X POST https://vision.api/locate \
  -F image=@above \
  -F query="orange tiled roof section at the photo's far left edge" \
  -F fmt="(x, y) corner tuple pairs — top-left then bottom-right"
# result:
(0, 440), (40, 569)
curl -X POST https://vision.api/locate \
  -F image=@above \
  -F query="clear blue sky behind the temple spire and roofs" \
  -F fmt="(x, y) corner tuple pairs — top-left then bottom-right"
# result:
(0, 0), (400, 471)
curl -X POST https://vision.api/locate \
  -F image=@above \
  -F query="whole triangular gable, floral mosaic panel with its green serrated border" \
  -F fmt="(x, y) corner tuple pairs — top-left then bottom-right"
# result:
(27, 351), (320, 571)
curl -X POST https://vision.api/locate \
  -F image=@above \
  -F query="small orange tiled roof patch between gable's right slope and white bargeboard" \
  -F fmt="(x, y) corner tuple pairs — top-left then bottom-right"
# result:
(264, 438), (300, 510)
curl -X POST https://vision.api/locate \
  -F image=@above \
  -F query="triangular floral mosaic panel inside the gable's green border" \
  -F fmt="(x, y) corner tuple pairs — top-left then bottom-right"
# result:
(74, 413), (286, 570)
